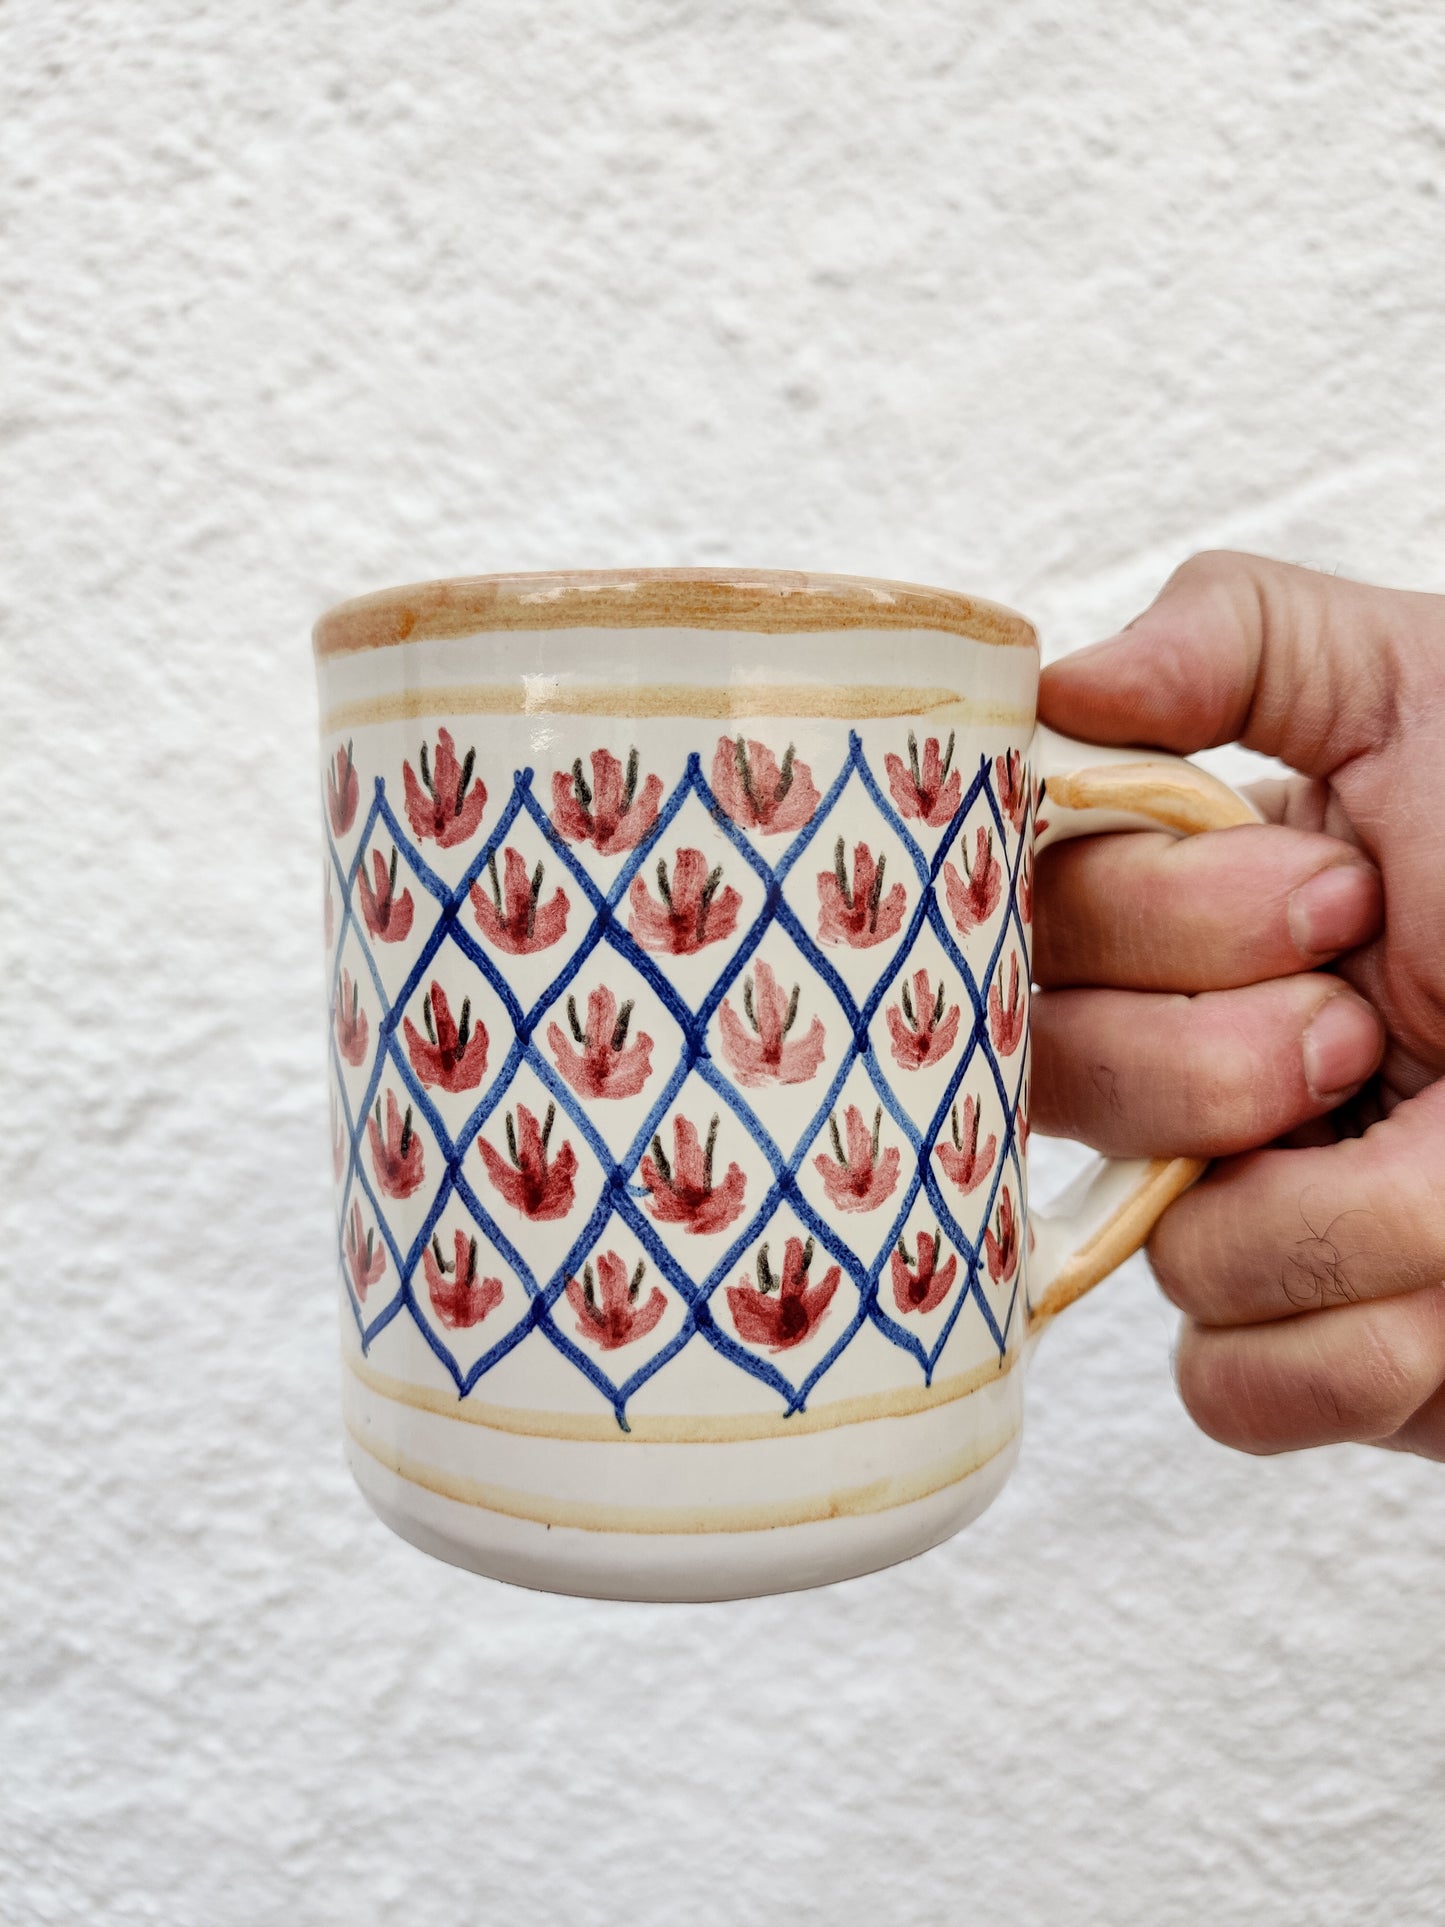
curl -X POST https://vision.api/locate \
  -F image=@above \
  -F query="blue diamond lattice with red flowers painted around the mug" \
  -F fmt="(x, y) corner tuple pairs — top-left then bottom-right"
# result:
(326, 732), (1038, 1426)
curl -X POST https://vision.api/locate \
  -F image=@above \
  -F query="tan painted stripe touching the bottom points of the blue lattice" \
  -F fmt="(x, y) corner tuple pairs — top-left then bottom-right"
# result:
(343, 1351), (1021, 1445)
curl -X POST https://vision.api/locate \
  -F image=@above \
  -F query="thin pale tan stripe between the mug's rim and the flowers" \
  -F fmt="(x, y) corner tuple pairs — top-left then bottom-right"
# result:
(322, 676), (1033, 730)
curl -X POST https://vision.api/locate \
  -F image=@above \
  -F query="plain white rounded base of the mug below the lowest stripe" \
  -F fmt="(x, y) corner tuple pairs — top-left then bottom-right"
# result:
(347, 1432), (1021, 1605)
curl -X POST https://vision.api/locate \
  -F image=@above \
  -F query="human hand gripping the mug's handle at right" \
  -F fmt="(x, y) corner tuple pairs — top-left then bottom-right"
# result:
(1033, 553), (1445, 1459)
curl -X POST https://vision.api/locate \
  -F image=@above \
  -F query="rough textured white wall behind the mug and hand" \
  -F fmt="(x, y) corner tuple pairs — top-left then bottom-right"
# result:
(0, 0), (1445, 1927)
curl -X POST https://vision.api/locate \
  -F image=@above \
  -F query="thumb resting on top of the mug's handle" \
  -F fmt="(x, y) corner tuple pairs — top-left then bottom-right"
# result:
(1038, 551), (1418, 777)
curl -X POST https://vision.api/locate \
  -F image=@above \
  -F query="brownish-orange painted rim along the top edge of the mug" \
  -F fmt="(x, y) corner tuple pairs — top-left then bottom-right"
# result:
(312, 568), (1038, 661)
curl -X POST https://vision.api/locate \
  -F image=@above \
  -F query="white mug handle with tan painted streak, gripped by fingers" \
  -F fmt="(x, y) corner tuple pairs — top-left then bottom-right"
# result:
(1029, 725), (1262, 1332)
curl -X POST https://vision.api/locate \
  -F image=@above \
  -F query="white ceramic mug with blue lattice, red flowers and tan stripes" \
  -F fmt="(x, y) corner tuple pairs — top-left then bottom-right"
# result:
(314, 570), (1254, 1599)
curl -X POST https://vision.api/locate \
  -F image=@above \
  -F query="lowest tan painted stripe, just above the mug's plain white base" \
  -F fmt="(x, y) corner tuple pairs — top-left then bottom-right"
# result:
(347, 1418), (1017, 1536)
